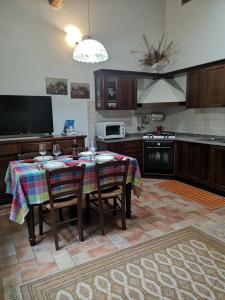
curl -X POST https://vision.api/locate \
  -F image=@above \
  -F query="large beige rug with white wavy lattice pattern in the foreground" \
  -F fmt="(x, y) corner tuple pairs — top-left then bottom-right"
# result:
(21, 227), (225, 300)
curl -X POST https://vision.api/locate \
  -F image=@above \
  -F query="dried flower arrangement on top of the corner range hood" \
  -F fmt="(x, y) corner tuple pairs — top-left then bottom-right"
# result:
(131, 33), (176, 67)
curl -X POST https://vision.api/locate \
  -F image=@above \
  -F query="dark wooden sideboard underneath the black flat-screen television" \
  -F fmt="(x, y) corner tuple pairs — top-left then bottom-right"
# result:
(0, 135), (86, 205)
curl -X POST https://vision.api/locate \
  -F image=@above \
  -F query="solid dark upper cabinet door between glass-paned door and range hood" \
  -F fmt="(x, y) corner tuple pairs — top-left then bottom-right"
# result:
(118, 76), (137, 109)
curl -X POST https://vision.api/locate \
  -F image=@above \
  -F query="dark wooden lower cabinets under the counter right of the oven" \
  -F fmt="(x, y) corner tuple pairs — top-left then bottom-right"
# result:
(175, 141), (225, 192)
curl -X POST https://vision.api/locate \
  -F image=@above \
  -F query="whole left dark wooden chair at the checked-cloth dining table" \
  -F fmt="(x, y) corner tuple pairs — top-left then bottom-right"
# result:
(39, 165), (85, 250)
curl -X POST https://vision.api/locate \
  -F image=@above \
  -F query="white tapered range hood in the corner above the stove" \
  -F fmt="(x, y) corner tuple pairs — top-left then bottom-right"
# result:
(137, 76), (187, 104)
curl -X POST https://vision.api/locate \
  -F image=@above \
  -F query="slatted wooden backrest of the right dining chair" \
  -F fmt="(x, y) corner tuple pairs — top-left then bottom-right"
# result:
(95, 159), (129, 197)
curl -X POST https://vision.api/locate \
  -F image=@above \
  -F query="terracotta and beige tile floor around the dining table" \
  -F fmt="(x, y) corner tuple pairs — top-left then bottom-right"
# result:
(0, 179), (225, 300)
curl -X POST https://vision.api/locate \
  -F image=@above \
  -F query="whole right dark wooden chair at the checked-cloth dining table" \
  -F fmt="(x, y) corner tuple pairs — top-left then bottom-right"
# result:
(86, 159), (129, 235)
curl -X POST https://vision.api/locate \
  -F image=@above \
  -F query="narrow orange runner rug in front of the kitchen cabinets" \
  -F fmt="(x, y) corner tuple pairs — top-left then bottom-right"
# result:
(156, 180), (225, 209)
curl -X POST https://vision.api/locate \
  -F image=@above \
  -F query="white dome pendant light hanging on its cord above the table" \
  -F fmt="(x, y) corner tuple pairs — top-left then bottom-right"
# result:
(73, 0), (108, 63)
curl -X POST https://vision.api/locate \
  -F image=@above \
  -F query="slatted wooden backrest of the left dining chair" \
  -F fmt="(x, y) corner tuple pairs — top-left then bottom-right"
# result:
(45, 165), (85, 205)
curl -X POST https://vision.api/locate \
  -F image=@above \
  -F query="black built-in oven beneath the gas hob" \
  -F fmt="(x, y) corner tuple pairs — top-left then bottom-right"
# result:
(144, 140), (174, 175)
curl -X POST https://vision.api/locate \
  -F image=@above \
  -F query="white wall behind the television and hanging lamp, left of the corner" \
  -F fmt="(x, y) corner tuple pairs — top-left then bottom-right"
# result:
(0, 0), (165, 134)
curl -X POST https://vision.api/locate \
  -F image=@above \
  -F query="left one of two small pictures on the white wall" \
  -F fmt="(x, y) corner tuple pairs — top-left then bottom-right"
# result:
(46, 78), (68, 95)
